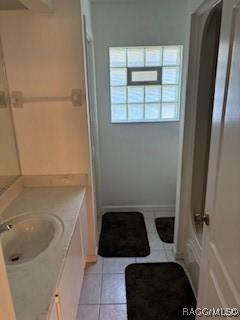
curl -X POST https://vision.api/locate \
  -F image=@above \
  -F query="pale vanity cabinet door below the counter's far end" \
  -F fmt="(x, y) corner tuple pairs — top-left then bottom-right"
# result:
(58, 219), (85, 320)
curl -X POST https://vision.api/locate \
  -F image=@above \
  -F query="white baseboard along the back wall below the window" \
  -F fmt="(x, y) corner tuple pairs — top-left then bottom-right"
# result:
(100, 205), (175, 217)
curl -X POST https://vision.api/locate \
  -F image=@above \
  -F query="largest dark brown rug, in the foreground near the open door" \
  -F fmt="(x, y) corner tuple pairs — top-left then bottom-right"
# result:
(125, 263), (196, 320)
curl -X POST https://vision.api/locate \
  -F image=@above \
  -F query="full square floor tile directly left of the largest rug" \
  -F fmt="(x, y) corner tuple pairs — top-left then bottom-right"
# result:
(101, 274), (126, 304)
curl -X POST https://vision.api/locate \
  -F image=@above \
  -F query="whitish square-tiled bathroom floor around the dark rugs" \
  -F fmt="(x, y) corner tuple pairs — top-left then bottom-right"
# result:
(77, 212), (174, 320)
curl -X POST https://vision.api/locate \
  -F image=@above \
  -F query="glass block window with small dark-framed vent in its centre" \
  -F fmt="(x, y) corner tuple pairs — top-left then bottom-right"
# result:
(109, 46), (182, 123)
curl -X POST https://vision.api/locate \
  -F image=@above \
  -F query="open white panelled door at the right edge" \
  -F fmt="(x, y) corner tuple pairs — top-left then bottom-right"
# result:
(198, 0), (240, 319)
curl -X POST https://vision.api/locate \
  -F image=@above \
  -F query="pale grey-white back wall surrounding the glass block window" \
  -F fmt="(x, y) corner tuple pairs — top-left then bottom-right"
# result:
(92, 0), (187, 210)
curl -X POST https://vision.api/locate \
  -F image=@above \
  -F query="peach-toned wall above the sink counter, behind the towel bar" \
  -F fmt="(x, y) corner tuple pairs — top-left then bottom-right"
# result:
(0, 0), (89, 175)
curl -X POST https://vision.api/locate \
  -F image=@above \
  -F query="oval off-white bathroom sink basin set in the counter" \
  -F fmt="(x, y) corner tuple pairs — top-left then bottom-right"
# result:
(1, 213), (63, 265)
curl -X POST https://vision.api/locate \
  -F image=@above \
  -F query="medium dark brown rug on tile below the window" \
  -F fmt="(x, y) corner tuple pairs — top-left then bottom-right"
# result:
(98, 212), (150, 257)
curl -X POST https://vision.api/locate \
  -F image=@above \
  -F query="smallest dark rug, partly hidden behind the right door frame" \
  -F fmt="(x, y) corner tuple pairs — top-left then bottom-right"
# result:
(155, 217), (175, 243)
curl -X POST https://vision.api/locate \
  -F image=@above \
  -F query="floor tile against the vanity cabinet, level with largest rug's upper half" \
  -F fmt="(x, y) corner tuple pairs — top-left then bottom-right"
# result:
(80, 274), (102, 304)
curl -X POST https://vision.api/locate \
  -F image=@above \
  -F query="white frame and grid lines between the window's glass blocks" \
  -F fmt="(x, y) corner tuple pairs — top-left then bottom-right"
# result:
(108, 44), (183, 124)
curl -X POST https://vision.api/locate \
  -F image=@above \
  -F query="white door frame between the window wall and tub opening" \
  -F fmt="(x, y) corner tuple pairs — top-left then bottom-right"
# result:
(174, 0), (222, 265)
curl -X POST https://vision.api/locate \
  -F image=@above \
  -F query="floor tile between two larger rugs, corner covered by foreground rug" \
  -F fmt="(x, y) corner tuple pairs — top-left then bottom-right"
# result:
(103, 258), (136, 273)
